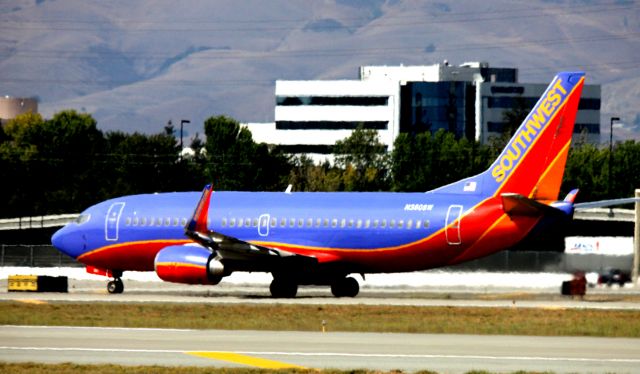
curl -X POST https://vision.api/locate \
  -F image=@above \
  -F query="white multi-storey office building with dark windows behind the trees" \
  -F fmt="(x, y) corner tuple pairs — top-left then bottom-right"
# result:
(245, 62), (600, 160)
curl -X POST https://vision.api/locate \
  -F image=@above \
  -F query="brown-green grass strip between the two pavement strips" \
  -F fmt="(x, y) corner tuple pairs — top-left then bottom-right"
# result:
(0, 302), (640, 338)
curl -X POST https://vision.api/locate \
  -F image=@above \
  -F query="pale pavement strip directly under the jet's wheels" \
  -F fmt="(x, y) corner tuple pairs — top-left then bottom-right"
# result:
(0, 280), (640, 310)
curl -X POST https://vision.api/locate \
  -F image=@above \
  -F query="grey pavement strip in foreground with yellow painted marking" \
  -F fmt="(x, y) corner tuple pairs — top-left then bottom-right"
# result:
(0, 326), (640, 373)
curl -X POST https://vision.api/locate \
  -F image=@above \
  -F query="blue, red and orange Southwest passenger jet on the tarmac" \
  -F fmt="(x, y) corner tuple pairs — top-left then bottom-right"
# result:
(52, 72), (584, 297)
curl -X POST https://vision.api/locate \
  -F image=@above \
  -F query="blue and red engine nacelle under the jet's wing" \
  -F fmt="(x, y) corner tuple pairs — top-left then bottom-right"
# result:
(154, 245), (225, 285)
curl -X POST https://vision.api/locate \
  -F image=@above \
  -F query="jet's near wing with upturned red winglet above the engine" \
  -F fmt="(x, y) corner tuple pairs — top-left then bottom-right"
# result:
(185, 184), (318, 271)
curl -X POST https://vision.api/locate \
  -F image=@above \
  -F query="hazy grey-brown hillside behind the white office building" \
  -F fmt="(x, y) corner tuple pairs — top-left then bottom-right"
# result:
(0, 0), (640, 139)
